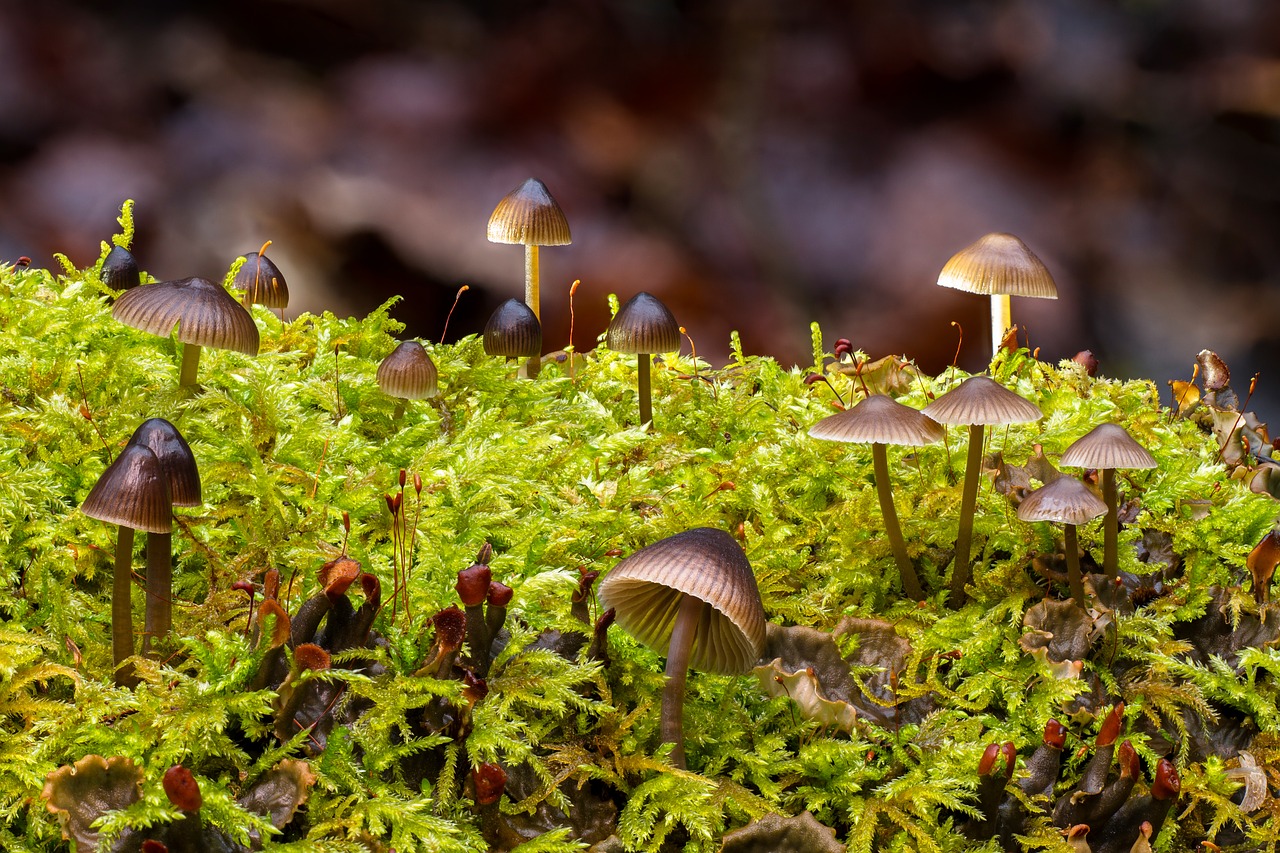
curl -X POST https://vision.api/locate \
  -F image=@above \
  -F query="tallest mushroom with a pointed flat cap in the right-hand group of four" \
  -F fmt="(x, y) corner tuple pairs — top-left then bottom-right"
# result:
(920, 377), (1044, 607)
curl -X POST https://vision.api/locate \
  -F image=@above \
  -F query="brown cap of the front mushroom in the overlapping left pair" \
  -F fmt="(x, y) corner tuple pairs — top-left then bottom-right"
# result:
(81, 444), (173, 533)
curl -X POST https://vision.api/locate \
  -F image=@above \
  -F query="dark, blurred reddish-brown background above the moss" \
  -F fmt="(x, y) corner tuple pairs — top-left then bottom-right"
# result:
(0, 0), (1280, 419)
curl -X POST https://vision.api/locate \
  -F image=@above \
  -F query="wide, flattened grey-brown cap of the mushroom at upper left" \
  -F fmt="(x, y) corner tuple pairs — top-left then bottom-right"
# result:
(111, 278), (257, 355)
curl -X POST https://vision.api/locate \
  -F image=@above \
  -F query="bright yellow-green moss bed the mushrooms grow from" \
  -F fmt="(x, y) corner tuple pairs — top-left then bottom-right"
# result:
(0, 208), (1280, 853)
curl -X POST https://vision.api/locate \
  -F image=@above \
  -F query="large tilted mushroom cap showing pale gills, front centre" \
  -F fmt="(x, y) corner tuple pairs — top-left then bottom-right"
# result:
(600, 528), (764, 674)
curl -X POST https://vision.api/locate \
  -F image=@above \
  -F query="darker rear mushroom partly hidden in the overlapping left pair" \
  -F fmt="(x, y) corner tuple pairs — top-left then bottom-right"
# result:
(129, 418), (201, 648)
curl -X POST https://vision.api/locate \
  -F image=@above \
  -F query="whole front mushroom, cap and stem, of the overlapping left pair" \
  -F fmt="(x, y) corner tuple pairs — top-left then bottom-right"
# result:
(81, 438), (173, 684)
